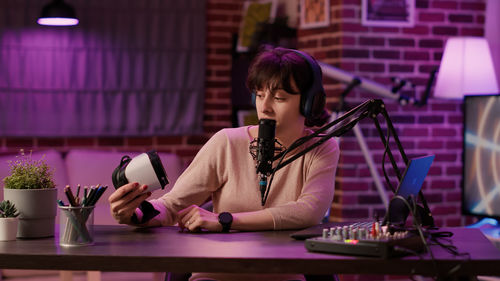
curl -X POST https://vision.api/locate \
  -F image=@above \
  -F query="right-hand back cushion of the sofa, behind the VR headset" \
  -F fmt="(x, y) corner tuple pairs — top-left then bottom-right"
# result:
(65, 149), (183, 224)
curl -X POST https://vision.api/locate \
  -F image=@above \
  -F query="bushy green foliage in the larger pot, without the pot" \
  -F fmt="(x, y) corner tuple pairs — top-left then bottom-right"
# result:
(3, 150), (56, 189)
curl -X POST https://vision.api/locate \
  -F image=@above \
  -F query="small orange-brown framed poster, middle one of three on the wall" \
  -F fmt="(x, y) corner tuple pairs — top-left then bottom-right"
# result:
(300, 0), (330, 28)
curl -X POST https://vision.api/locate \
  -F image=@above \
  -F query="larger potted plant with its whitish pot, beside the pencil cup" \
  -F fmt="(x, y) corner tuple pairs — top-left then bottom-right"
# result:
(3, 150), (57, 238)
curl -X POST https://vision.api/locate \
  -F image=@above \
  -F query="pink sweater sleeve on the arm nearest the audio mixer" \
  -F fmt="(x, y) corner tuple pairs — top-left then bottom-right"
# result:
(267, 139), (340, 230)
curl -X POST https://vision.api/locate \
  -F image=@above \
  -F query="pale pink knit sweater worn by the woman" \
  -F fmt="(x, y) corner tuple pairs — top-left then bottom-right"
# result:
(151, 127), (340, 230)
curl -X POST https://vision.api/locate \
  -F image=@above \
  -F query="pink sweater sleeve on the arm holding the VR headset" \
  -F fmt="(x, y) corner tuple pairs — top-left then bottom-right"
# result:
(146, 130), (227, 225)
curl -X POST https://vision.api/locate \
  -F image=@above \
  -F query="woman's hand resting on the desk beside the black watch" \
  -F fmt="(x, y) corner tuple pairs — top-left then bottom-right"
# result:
(177, 205), (222, 232)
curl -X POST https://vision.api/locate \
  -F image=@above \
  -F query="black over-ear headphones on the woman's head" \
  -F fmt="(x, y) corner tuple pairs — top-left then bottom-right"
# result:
(252, 49), (325, 118)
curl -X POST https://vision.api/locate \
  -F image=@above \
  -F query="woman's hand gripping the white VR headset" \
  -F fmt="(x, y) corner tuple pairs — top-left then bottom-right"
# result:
(108, 182), (151, 224)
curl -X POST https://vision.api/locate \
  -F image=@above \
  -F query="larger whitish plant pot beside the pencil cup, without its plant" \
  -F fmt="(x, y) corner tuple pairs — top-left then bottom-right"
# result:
(4, 188), (57, 238)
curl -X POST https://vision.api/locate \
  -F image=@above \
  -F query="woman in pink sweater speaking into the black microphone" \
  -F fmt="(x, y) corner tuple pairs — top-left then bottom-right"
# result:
(109, 48), (339, 280)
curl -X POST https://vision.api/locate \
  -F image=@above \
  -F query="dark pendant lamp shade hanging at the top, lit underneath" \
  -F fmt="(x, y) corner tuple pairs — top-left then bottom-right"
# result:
(37, 0), (78, 26)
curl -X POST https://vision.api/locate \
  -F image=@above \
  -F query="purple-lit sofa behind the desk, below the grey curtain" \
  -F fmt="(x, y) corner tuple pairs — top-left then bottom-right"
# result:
(0, 149), (184, 225)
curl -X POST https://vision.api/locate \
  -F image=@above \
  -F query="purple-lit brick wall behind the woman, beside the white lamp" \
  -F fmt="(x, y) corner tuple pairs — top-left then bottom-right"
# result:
(299, 0), (486, 226)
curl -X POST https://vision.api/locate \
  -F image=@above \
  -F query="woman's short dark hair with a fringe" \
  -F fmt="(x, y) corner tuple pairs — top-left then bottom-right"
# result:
(246, 47), (330, 127)
